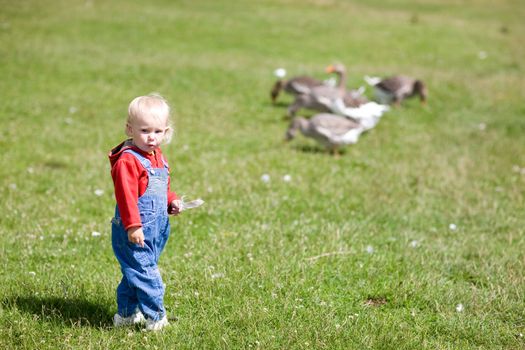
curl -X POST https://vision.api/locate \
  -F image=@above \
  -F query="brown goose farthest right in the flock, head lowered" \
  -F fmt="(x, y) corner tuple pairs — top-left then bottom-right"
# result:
(364, 75), (428, 106)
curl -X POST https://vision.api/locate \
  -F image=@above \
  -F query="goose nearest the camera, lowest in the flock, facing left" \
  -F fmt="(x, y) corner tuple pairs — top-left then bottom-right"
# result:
(286, 113), (365, 155)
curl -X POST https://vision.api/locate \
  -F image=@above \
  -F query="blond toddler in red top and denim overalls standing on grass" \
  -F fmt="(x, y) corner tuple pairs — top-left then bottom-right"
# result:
(109, 94), (181, 331)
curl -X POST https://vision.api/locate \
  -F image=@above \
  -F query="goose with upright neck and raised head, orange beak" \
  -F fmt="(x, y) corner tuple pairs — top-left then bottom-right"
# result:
(288, 64), (346, 117)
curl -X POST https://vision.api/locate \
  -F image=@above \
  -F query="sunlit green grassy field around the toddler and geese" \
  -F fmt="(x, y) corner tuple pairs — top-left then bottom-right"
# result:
(0, 0), (525, 349)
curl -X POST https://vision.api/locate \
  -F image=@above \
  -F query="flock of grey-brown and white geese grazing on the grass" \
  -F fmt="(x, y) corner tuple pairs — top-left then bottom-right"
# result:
(270, 64), (428, 155)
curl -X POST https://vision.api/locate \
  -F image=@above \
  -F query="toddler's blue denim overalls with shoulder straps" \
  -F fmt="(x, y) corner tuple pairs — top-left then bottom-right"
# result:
(111, 149), (170, 321)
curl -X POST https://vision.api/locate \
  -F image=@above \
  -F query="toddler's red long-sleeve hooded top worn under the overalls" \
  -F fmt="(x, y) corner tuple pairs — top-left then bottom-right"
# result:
(109, 140), (179, 230)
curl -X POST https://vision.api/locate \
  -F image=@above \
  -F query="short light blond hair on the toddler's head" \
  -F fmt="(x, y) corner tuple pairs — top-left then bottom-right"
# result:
(126, 92), (173, 143)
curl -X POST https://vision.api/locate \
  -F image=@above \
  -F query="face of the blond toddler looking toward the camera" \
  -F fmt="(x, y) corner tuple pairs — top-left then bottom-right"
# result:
(127, 116), (168, 153)
